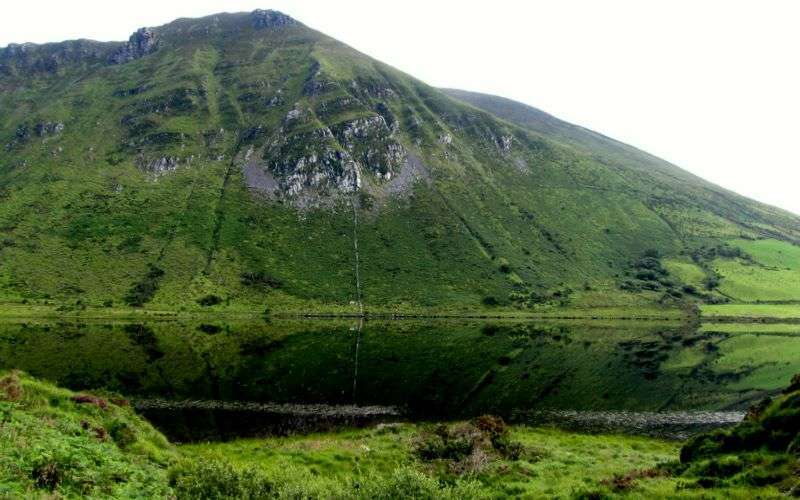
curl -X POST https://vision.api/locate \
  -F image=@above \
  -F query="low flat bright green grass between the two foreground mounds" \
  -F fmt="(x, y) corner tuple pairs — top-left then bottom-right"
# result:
(180, 423), (778, 498)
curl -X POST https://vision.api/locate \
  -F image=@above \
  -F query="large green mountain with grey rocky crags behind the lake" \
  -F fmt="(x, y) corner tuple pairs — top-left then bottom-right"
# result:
(0, 10), (800, 312)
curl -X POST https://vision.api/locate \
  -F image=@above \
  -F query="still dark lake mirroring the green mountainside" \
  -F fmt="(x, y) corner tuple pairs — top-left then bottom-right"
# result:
(0, 319), (800, 440)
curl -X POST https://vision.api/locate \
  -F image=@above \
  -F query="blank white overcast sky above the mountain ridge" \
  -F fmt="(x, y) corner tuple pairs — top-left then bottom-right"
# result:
(0, 0), (800, 214)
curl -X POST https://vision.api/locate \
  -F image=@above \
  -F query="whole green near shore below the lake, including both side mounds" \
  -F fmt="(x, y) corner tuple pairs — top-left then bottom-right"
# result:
(0, 372), (797, 499)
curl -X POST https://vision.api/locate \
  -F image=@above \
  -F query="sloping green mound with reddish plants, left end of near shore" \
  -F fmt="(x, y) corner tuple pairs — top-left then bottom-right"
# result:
(0, 372), (177, 498)
